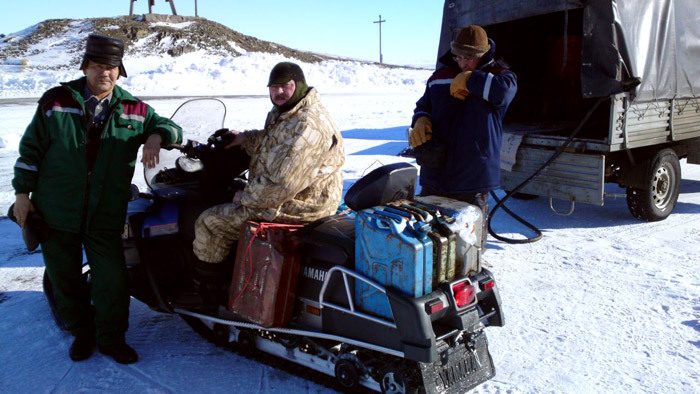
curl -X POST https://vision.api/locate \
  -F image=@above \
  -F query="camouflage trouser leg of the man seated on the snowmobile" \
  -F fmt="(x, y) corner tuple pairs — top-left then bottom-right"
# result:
(192, 203), (262, 263)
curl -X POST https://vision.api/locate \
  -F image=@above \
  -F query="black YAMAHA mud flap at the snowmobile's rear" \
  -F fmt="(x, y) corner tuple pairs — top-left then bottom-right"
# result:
(419, 331), (496, 393)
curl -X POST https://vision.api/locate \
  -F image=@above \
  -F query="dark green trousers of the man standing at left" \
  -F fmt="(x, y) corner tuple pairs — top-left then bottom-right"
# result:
(41, 229), (130, 346)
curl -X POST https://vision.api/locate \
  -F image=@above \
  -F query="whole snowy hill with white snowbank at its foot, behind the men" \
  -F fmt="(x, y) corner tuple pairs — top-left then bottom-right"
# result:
(0, 15), (429, 99)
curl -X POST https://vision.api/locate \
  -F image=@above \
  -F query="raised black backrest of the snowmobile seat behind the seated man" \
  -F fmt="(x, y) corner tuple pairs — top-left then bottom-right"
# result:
(345, 163), (418, 211)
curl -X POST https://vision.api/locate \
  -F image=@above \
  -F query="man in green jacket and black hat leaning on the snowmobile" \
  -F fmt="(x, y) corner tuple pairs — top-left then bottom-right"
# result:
(12, 34), (182, 364)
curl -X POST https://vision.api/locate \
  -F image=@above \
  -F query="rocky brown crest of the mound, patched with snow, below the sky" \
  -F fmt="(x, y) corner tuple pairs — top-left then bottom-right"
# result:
(0, 14), (334, 67)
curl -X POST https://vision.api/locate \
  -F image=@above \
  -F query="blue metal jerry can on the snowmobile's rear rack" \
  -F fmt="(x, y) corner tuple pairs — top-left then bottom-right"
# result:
(355, 207), (433, 319)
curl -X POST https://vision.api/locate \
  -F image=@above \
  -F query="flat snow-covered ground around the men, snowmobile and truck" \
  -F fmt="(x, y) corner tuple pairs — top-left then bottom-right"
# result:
(0, 37), (700, 393)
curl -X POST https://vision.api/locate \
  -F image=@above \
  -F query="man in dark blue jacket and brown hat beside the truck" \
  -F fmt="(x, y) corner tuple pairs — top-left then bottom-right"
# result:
(409, 25), (517, 247)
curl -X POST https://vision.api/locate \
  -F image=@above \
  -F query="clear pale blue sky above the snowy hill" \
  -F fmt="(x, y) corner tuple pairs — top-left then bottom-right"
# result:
(0, 0), (443, 64)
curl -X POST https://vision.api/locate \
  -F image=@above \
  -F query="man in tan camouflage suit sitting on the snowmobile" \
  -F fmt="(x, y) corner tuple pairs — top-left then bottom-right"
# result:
(193, 62), (345, 263)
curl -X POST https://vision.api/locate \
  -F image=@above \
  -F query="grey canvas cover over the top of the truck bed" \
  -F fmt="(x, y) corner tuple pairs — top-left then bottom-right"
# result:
(438, 0), (700, 101)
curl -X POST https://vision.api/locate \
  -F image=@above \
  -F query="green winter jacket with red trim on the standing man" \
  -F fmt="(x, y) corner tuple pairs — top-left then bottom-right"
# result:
(12, 77), (182, 232)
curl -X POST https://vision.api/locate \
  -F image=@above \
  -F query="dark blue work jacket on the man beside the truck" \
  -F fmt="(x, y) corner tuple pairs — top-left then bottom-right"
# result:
(412, 39), (518, 194)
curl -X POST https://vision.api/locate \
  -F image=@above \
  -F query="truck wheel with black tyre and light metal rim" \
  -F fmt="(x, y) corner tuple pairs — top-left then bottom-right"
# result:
(627, 149), (681, 222)
